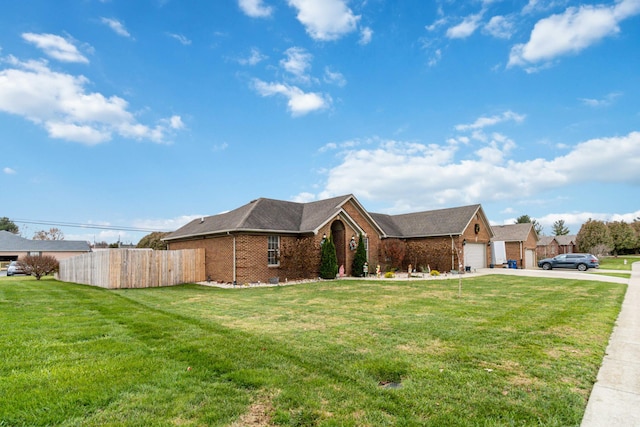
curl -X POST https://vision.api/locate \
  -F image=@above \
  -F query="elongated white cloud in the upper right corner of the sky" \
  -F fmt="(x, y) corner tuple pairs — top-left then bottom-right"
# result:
(508, 0), (640, 67)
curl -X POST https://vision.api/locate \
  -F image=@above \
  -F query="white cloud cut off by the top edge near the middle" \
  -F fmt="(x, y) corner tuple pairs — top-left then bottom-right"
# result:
(288, 0), (360, 41)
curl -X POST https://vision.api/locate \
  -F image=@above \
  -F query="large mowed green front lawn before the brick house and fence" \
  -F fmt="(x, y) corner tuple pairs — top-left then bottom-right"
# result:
(0, 276), (626, 426)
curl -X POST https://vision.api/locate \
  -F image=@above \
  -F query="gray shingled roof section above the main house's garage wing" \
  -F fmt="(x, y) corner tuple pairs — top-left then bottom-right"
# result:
(371, 205), (481, 238)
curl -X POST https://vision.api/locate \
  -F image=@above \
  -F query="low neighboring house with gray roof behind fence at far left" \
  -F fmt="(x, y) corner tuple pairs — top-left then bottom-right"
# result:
(0, 230), (91, 261)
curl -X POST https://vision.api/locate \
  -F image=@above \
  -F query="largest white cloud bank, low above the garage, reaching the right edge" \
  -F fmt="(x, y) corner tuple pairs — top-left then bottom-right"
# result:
(312, 132), (640, 209)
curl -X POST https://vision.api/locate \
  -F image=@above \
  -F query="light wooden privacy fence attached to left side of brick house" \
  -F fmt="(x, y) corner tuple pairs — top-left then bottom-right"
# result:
(58, 249), (205, 289)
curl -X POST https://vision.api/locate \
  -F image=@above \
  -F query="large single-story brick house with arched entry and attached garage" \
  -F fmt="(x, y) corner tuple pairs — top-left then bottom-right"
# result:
(163, 194), (493, 283)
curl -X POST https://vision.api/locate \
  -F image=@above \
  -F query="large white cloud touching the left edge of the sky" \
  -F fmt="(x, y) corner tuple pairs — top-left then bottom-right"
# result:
(0, 56), (183, 145)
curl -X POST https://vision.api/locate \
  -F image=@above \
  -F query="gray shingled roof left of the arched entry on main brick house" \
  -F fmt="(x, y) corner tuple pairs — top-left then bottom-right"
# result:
(163, 195), (354, 240)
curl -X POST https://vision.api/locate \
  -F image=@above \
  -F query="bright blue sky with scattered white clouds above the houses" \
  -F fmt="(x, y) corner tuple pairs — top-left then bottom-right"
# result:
(0, 0), (640, 243)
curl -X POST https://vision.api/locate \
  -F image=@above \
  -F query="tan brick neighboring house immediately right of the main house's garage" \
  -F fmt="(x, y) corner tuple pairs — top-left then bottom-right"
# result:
(491, 223), (538, 268)
